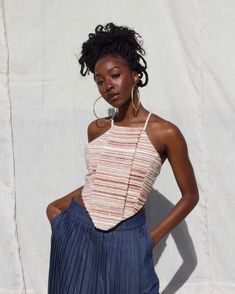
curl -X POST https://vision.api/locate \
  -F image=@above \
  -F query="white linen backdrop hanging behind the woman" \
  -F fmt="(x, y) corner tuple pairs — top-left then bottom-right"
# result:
(0, 0), (235, 294)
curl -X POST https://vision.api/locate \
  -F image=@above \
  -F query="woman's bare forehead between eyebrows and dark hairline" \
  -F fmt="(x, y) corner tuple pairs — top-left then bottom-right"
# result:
(94, 55), (129, 76)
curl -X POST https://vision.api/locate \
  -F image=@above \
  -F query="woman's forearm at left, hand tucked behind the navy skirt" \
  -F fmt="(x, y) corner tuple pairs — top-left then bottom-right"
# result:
(46, 186), (83, 221)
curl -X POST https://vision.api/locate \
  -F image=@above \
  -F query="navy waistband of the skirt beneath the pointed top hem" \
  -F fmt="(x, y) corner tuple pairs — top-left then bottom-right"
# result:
(68, 196), (146, 232)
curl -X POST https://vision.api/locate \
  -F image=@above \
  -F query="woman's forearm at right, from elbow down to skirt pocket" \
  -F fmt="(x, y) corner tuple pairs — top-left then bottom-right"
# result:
(150, 195), (199, 245)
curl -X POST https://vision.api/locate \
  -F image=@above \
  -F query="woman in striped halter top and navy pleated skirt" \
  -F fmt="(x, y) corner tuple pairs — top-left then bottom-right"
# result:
(47, 23), (199, 294)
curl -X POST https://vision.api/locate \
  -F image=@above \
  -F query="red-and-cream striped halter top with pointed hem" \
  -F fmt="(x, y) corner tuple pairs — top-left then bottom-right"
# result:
(82, 112), (161, 230)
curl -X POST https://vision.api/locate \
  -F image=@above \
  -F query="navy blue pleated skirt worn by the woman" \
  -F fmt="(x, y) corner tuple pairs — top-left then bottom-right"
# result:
(48, 197), (159, 294)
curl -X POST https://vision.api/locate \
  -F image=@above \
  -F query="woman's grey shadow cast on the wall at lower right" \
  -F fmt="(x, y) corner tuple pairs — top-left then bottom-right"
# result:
(145, 189), (197, 294)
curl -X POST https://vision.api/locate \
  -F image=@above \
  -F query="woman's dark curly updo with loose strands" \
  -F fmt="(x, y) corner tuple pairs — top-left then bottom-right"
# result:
(76, 22), (148, 87)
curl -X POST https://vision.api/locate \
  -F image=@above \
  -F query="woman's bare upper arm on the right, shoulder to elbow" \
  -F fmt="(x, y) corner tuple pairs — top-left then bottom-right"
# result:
(166, 123), (198, 199)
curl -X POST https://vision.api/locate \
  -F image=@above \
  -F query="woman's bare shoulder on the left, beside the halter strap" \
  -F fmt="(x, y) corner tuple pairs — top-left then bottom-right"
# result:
(87, 117), (111, 142)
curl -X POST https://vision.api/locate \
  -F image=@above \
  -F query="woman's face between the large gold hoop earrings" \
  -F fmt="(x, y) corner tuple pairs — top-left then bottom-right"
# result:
(94, 55), (138, 107)
